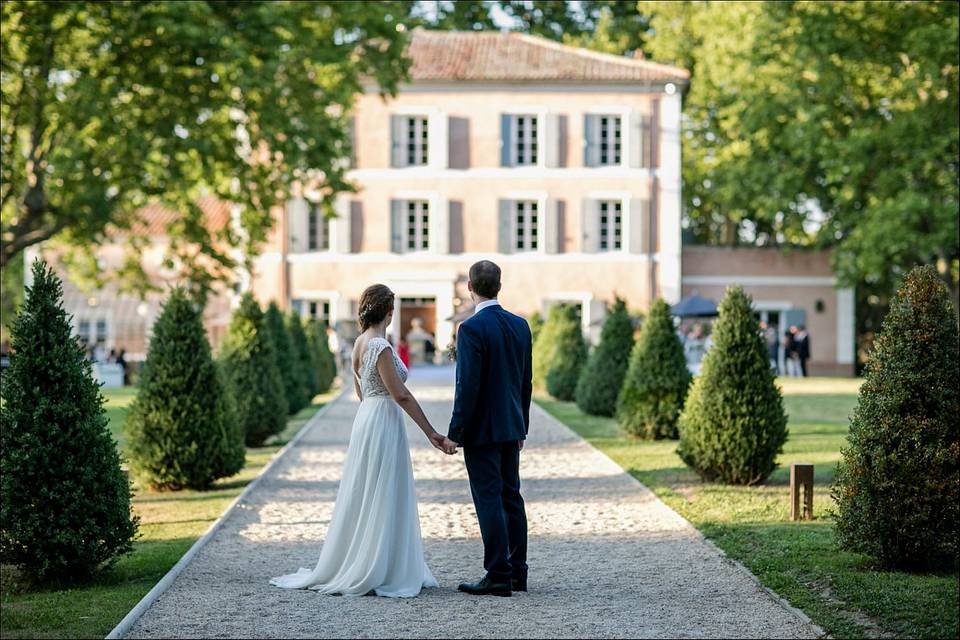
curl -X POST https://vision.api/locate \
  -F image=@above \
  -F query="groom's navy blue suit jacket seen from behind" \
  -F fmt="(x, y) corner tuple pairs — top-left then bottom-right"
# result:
(448, 305), (533, 447)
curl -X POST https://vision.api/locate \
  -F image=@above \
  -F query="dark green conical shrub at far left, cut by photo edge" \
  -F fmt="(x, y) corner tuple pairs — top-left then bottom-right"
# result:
(0, 260), (138, 582)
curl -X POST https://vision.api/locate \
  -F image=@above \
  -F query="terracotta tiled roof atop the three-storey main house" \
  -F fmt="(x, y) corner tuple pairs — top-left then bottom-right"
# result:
(407, 28), (690, 83)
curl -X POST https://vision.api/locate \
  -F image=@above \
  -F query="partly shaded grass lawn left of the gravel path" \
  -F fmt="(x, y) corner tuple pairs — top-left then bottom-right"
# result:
(0, 389), (337, 638)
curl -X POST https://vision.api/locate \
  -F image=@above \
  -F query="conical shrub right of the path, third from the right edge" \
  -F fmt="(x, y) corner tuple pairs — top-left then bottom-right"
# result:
(617, 300), (690, 439)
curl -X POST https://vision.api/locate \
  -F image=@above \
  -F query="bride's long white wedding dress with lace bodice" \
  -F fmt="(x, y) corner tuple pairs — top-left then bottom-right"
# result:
(270, 338), (438, 598)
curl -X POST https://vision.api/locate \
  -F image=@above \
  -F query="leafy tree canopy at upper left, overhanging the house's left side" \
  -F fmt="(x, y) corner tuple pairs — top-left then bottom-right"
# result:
(0, 0), (409, 292)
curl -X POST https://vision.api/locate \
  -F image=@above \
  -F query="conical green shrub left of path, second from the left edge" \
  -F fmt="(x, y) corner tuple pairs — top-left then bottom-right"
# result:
(124, 289), (246, 490)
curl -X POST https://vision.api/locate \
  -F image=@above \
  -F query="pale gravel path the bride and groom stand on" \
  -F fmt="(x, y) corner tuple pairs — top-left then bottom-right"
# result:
(128, 368), (819, 638)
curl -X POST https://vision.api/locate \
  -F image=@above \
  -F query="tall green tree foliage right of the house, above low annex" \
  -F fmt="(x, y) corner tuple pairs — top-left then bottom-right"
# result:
(639, 2), (960, 350)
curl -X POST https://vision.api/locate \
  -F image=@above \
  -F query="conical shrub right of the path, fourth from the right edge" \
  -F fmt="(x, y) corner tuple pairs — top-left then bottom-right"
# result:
(576, 298), (633, 416)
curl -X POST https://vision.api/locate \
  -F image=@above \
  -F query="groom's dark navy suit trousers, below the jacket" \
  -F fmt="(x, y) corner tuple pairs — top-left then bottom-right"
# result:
(463, 441), (527, 580)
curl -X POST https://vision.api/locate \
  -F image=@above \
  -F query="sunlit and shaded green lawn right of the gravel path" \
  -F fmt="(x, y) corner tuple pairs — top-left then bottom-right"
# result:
(537, 378), (960, 638)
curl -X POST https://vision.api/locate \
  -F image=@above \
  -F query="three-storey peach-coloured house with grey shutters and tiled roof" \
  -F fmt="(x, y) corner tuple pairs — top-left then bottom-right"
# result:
(250, 30), (688, 349)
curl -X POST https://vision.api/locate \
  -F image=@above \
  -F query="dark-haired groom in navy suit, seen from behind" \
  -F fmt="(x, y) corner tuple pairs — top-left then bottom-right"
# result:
(447, 260), (533, 596)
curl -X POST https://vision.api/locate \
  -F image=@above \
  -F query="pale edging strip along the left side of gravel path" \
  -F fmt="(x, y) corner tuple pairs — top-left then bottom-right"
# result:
(106, 385), (348, 640)
